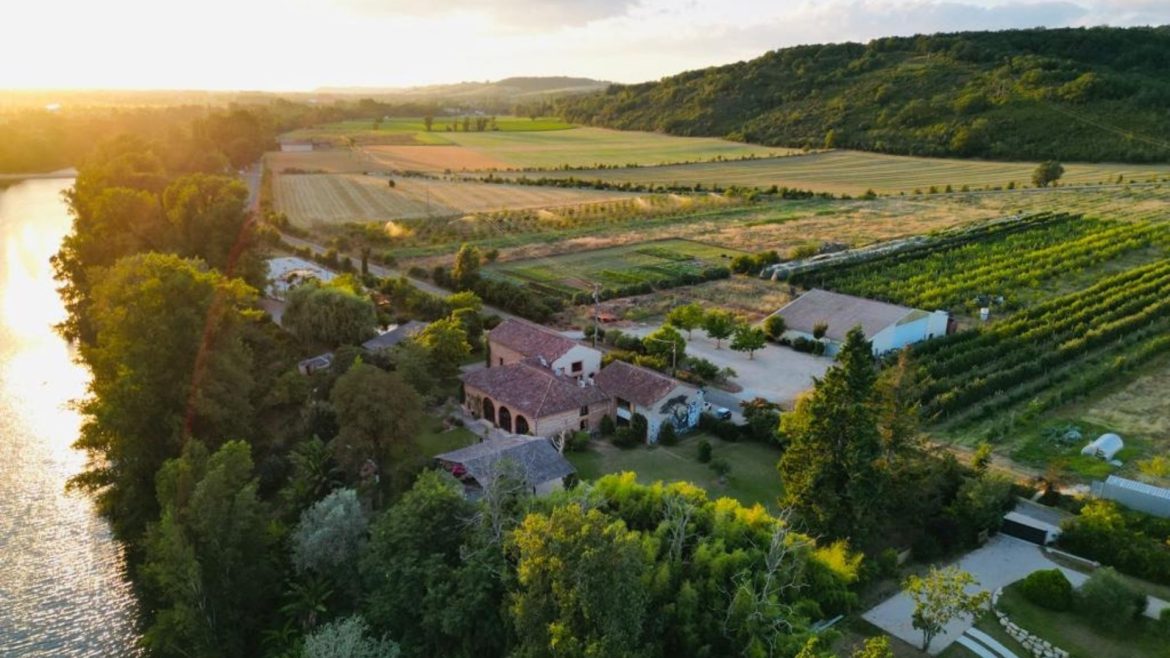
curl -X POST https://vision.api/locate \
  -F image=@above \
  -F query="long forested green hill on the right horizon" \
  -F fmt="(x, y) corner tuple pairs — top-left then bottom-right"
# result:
(559, 26), (1170, 162)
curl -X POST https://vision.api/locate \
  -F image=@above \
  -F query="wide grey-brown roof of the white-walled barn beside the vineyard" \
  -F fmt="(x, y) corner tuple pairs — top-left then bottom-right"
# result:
(775, 289), (922, 342)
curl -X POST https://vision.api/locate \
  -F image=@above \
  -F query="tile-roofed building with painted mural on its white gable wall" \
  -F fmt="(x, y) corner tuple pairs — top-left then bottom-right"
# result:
(597, 361), (704, 443)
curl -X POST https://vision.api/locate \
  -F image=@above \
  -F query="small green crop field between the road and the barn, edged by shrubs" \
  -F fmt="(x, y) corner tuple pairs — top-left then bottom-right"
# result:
(487, 240), (743, 295)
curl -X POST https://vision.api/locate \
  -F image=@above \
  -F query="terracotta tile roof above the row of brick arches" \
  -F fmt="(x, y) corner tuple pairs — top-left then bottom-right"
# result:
(462, 361), (608, 420)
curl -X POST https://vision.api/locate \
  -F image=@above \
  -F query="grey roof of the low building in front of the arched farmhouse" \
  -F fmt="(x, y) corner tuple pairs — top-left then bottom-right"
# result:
(435, 437), (577, 485)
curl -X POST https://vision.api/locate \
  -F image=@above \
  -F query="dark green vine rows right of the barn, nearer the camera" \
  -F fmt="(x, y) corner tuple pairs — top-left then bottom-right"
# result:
(914, 259), (1170, 421)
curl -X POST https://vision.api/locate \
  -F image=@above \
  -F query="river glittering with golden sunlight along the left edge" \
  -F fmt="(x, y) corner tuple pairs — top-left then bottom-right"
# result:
(0, 179), (137, 658)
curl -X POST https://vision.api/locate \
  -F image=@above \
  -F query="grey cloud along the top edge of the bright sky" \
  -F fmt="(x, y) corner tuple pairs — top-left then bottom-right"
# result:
(342, 0), (639, 29)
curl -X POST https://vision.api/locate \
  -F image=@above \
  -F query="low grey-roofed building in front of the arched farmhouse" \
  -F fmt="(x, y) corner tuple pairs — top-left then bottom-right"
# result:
(435, 437), (576, 499)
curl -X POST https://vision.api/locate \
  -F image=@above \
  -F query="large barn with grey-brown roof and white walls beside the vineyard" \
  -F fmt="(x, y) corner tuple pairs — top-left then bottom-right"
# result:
(773, 289), (950, 355)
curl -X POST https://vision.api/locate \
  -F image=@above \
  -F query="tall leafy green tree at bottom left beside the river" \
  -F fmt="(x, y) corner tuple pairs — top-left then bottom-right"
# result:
(142, 441), (280, 658)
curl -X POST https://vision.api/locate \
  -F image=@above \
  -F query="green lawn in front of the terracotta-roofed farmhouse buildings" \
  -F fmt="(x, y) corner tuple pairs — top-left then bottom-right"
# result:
(566, 433), (784, 512)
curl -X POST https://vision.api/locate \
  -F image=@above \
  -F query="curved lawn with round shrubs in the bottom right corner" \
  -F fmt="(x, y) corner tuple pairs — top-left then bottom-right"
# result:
(999, 585), (1170, 658)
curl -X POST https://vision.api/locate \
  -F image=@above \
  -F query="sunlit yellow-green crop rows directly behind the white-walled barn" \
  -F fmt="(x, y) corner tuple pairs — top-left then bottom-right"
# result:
(793, 214), (1170, 311)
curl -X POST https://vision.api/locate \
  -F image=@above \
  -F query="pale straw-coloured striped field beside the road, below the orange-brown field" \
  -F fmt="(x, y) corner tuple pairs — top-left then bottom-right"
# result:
(275, 173), (629, 227)
